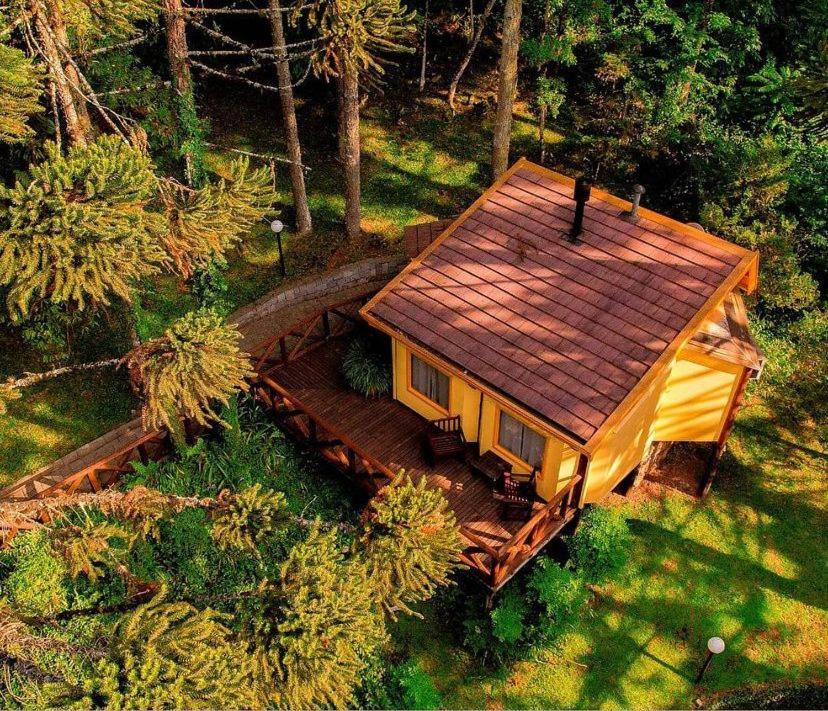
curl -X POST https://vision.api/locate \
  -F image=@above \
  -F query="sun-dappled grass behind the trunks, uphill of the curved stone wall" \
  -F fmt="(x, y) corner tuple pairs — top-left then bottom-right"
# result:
(0, 87), (555, 486)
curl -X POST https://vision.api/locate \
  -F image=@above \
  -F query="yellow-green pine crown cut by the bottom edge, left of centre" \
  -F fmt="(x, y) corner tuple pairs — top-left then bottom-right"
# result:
(58, 593), (256, 709)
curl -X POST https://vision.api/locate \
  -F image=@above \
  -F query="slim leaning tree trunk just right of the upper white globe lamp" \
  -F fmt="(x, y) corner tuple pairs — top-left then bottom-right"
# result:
(268, 0), (313, 235)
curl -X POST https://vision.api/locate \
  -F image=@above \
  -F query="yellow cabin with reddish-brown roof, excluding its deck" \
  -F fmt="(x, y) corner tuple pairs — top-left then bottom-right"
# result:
(360, 159), (762, 506)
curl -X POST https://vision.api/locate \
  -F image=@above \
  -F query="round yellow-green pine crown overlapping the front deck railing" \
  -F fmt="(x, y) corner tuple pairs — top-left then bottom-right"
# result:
(363, 474), (463, 612)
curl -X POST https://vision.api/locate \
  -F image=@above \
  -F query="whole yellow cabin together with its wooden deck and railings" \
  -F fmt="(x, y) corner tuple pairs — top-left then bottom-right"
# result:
(252, 160), (762, 592)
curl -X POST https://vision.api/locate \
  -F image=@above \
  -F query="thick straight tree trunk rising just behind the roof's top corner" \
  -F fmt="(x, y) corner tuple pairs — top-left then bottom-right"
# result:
(492, 0), (523, 178)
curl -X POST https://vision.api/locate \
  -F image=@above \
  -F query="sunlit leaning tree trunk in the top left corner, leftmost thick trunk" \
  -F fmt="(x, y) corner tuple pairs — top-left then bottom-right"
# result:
(31, 0), (92, 146)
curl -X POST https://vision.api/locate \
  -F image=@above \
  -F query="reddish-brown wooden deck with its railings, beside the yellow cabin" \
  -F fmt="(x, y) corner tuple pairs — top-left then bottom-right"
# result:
(254, 308), (581, 590)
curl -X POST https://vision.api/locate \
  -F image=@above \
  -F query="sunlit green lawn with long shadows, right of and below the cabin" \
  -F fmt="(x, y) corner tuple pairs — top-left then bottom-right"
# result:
(395, 408), (828, 708)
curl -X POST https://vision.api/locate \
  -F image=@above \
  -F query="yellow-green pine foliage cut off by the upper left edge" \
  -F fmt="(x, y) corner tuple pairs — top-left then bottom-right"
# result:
(0, 40), (43, 143)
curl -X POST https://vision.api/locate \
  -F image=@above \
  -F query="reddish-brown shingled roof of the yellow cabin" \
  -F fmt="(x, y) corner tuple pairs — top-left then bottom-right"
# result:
(363, 160), (756, 443)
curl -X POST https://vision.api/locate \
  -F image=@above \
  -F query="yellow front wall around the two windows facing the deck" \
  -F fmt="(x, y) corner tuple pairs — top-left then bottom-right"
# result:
(392, 339), (578, 499)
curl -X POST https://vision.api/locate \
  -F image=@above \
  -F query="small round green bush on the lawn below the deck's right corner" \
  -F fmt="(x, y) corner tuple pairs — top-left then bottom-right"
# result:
(569, 507), (630, 583)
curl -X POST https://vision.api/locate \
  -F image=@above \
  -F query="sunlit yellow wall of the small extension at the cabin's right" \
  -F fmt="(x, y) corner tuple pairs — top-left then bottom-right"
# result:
(653, 350), (742, 442)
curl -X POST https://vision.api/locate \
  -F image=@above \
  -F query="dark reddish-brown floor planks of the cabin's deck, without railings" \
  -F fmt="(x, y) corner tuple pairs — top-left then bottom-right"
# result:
(267, 338), (523, 548)
